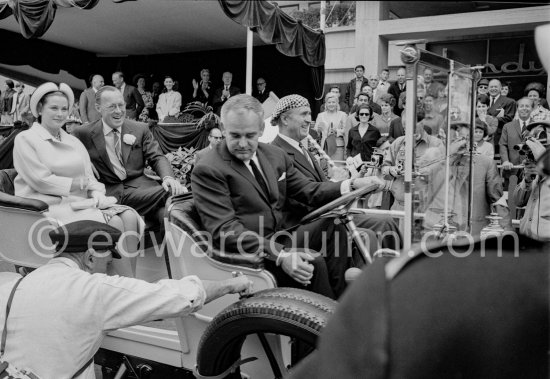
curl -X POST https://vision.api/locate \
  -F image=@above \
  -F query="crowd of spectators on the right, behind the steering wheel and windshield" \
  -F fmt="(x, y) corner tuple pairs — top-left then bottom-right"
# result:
(311, 65), (550, 226)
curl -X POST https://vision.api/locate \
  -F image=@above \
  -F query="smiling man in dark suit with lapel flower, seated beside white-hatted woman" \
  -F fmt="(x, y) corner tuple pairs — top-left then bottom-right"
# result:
(73, 86), (185, 221)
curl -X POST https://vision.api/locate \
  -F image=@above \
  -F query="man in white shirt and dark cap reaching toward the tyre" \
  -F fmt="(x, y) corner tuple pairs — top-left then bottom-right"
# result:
(0, 221), (250, 379)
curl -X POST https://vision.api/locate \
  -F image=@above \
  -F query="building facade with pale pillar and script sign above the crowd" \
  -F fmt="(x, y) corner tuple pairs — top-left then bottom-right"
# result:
(278, 1), (550, 99)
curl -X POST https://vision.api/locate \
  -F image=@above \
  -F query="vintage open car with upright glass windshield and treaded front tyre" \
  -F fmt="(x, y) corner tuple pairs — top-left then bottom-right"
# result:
(0, 45), (528, 378)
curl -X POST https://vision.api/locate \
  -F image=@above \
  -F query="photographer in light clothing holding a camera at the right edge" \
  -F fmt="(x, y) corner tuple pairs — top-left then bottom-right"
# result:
(514, 121), (550, 241)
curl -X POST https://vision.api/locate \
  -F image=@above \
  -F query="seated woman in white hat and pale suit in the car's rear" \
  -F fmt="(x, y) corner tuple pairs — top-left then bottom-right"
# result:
(13, 82), (143, 276)
